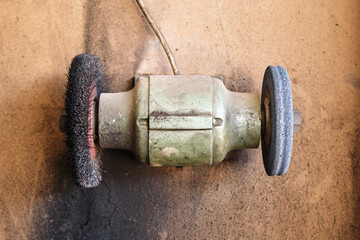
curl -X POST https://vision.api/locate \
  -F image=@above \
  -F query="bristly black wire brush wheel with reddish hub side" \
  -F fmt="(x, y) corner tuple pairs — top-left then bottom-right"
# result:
(65, 54), (102, 188)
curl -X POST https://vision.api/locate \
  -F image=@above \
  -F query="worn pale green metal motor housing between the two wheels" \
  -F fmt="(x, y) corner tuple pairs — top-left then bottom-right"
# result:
(97, 75), (261, 166)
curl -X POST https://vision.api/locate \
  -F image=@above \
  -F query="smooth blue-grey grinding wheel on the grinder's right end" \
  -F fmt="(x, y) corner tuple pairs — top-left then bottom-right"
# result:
(261, 66), (293, 176)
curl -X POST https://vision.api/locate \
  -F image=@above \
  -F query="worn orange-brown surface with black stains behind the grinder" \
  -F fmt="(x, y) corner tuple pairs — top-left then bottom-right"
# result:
(0, 0), (360, 239)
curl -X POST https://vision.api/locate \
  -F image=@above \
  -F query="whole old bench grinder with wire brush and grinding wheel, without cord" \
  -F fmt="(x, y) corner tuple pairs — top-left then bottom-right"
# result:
(60, 54), (301, 187)
